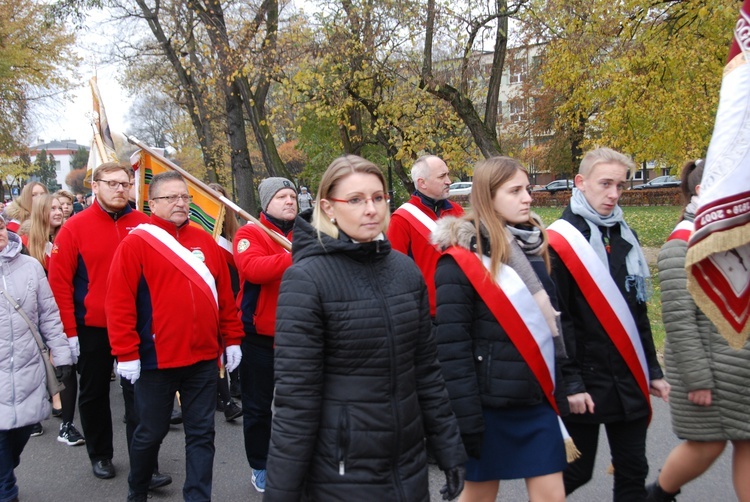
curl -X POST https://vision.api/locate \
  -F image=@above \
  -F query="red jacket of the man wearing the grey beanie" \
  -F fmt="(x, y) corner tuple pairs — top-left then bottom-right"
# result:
(233, 213), (292, 336)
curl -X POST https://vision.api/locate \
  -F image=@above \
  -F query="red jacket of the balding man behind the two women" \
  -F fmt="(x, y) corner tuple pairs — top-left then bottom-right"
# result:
(388, 193), (464, 317)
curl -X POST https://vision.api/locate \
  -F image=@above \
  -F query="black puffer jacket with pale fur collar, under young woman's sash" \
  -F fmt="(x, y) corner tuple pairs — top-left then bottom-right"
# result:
(432, 218), (568, 446)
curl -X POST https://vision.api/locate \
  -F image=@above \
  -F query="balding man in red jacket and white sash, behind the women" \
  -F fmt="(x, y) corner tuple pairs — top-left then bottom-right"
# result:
(388, 155), (464, 319)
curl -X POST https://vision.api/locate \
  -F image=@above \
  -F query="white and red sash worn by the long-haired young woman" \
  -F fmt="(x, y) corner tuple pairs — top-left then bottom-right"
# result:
(445, 246), (560, 415)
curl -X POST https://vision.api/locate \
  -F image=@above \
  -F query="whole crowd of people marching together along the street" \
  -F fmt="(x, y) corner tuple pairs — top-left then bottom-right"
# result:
(0, 148), (750, 502)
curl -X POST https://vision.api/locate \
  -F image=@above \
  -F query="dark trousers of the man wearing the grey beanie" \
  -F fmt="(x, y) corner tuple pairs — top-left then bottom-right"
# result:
(240, 334), (273, 469)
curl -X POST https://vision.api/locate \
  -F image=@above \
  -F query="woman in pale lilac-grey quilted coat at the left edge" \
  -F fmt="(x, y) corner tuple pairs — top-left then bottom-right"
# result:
(0, 217), (72, 502)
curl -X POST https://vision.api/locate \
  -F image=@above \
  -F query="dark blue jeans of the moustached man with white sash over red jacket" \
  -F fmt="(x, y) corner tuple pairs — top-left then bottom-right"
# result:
(128, 361), (217, 502)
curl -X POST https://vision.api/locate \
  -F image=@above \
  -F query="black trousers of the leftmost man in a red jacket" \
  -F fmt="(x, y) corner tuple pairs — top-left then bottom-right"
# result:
(77, 326), (114, 463)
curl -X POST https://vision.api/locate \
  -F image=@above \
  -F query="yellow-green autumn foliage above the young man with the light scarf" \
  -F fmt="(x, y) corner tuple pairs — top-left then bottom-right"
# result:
(524, 0), (737, 167)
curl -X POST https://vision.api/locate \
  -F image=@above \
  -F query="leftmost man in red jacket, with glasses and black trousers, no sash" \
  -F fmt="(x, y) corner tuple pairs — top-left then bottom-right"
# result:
(49, 162), (148, 479)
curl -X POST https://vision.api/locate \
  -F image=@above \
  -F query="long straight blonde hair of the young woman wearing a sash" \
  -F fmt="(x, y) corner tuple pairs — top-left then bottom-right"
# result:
(463, 157), (549, 277)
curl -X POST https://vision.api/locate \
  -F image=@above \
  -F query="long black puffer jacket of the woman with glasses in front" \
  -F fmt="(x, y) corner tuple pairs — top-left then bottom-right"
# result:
(264, 218), (466, 502)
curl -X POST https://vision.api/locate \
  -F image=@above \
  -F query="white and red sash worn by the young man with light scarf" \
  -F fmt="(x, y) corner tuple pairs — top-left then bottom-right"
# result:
(547, 220), (651, 406)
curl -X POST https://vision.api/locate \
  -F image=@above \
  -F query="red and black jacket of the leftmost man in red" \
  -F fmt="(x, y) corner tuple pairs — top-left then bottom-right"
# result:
(49, 201), (148, 337)
